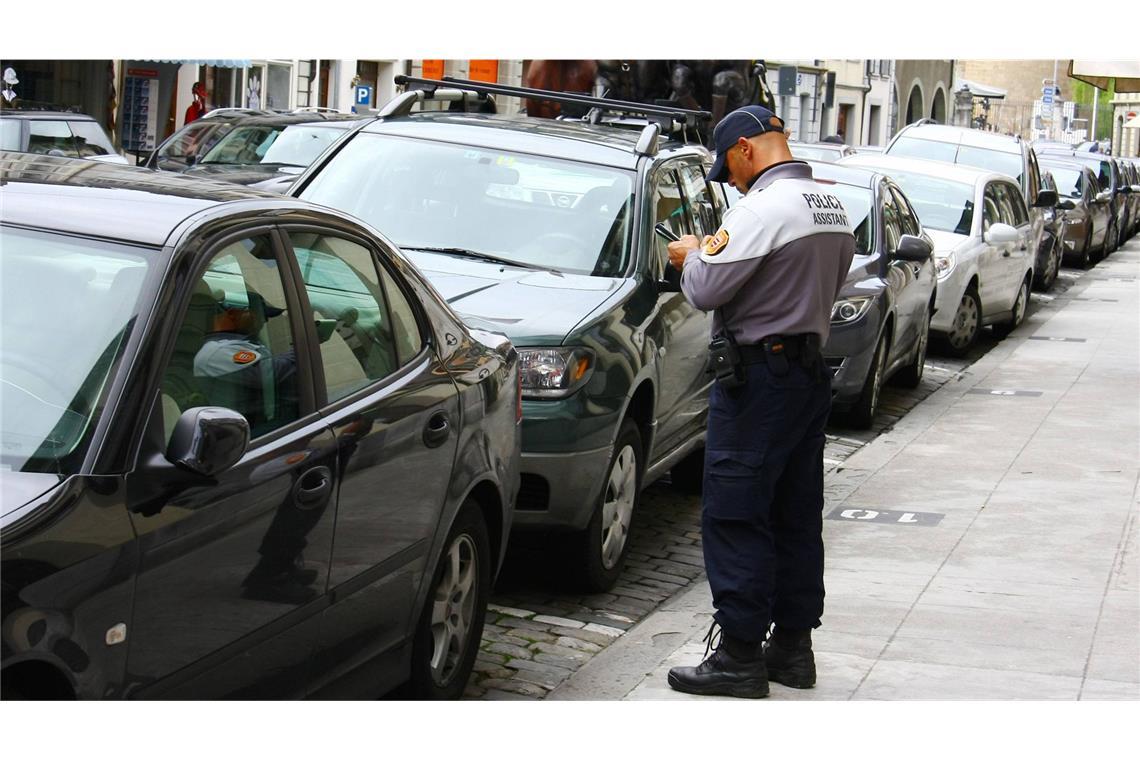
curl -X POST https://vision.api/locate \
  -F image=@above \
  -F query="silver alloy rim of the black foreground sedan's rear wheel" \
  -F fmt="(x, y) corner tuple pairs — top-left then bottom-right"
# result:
(430, 533), (479, 685)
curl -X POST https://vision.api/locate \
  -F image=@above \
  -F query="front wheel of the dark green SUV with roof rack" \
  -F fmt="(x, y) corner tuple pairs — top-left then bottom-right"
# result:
(568, 417), (644, 593)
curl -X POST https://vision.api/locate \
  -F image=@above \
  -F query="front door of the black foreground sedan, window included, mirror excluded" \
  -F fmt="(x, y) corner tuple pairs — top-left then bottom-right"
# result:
(128, 228), (340, 698)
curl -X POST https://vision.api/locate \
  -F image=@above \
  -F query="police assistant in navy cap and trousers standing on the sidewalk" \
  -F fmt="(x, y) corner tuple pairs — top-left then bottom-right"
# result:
(669, 106), (855, 697)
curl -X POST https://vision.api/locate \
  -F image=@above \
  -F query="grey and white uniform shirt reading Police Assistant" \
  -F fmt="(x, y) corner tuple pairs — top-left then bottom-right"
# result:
(681, 161), (855, 344)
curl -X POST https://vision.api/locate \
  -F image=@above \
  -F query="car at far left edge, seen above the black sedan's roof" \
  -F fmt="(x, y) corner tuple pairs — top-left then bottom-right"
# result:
(0, 108), (129, 164)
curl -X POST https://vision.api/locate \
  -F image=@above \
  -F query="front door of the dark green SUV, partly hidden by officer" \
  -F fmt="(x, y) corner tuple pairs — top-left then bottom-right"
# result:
(645, 161), (709, 461)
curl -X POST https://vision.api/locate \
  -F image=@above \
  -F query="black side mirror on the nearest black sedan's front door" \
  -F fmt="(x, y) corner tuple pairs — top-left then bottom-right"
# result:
(166, 407), (250, 477)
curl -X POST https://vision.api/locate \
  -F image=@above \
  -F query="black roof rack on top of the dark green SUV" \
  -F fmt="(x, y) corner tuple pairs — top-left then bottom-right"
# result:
(394, 74), (713, 155)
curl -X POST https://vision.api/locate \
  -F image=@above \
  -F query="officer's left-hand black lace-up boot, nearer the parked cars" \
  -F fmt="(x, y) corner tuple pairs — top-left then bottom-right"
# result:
(669, 623), (768, 700)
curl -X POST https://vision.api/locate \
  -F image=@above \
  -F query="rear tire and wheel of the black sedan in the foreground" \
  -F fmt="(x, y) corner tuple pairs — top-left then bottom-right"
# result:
(406, 499), (494, 700)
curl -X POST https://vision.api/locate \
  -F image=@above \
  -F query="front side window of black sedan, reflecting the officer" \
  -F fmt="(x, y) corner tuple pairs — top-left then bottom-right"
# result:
(162, 235), (300, 440)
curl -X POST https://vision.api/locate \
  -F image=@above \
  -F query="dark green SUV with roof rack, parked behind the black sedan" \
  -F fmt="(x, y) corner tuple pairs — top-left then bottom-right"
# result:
(290, 79), (725, 590)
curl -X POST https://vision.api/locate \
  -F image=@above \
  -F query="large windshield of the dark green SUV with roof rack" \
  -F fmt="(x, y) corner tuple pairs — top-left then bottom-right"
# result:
(301, 133), (632, 277)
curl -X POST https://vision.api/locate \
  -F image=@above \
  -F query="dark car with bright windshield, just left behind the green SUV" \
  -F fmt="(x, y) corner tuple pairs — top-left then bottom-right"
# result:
(186, 114), (361, 193)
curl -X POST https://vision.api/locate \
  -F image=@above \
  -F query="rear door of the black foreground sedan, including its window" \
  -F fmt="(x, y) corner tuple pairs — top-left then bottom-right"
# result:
(283, 227), (465, 696)
